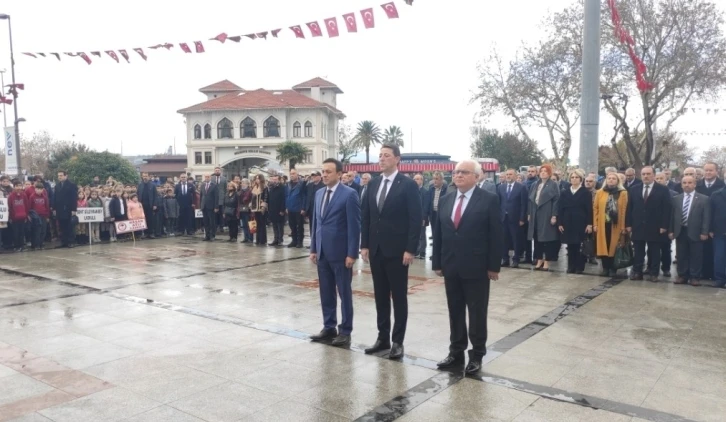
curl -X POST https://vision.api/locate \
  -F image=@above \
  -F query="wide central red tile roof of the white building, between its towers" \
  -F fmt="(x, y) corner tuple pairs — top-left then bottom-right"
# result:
(177, 89), (344, 116)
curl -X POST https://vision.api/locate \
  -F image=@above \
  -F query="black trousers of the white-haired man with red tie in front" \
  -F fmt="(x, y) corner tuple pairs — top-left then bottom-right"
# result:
(444, 277), (489, 362)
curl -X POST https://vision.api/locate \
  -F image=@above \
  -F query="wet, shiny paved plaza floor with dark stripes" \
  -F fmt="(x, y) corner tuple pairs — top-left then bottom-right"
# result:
(0, 238), (726, 422)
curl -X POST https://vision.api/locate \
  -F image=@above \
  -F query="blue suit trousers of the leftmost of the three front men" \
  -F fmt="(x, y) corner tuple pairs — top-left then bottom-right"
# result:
(318, 253), (353, 335)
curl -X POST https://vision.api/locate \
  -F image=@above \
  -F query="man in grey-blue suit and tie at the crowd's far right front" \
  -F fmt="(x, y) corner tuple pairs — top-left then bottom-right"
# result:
(668, 176), (711, 286)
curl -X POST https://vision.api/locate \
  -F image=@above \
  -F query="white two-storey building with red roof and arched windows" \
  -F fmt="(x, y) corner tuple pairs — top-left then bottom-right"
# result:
(178, 78), (345, 178)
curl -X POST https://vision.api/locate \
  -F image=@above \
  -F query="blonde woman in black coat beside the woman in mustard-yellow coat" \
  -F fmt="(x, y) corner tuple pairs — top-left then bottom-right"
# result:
(557, 169), (592, 274)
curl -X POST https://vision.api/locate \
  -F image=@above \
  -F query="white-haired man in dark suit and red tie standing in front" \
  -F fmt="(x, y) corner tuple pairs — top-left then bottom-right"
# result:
(431, 160), (504, 374)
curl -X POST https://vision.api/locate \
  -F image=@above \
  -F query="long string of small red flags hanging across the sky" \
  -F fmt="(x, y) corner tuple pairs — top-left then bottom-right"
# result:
(22, 0), (414, 65)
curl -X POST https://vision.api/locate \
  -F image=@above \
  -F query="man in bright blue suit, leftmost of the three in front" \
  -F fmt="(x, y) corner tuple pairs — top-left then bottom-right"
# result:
(310, 158), (361, 347)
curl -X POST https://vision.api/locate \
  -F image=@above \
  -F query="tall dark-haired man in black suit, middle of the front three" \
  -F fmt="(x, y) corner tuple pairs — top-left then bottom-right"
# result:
(360, 144), (423, 359)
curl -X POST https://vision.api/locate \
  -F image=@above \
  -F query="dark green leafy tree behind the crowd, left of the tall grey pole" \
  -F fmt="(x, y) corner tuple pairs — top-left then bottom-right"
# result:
(471, 127), (542, 169)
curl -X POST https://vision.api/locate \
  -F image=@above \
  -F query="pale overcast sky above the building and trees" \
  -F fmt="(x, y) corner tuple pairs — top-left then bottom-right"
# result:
(0, 0), (726, 163)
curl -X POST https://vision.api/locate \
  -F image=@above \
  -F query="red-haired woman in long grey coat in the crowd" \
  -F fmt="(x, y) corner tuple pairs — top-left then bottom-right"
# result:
(527, 164), (560, 271)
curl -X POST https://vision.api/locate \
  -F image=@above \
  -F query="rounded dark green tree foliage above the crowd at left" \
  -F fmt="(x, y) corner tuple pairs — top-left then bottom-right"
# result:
(61, 151), (139, 186)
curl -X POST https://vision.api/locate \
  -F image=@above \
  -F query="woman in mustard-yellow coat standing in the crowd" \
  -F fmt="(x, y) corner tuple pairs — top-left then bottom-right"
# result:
(592, 173), (628, 277)
